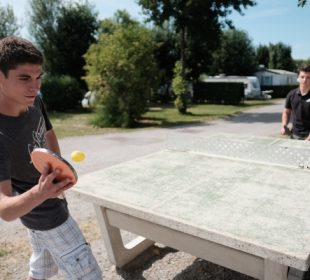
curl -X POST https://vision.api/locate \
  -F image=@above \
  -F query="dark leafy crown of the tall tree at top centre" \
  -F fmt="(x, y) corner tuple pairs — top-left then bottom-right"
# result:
(138, 0), (255, 77)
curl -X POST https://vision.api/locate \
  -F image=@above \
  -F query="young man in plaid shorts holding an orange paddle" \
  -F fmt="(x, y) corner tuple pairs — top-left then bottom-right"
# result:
(0, 37), (102, 280)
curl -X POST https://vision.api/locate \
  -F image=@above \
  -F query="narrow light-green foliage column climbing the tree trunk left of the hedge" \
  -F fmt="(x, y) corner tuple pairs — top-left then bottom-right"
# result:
(172, 61), (188, 114)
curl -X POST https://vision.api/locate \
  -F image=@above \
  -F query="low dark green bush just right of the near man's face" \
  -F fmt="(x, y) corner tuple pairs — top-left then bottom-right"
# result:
(41, 75), (83, 112)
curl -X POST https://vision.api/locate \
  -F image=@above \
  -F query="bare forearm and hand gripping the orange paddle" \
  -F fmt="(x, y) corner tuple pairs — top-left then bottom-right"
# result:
(0, 166), (72, 221)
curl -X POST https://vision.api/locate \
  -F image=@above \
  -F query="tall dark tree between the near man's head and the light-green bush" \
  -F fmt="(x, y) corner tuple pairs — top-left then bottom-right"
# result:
(30, 0), (98, 89)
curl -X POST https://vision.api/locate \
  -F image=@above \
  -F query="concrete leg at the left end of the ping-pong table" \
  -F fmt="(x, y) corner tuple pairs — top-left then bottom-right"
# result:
(94, 205), (155, 267)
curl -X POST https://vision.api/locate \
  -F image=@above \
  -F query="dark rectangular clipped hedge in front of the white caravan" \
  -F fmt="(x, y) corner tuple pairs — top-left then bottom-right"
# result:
(193, 82), (244, 105)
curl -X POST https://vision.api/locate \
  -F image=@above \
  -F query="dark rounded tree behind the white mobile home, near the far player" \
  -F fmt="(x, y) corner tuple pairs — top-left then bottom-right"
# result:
(269, 42), (296, 71)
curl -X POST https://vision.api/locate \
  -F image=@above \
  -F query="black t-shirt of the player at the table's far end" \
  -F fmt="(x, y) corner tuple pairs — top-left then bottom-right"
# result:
(285, 88), (310, 137)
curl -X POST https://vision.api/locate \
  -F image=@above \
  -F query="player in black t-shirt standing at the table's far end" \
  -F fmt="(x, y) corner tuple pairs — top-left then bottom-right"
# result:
(281, 65), (310, 141)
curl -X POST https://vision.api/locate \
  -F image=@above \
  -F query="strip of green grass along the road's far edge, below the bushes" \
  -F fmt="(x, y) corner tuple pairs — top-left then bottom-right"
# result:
(50, 100), (273, 138)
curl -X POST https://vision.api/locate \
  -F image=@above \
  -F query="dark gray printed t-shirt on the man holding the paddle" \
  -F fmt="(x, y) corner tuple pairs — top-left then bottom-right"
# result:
(0, 97), (68, 230)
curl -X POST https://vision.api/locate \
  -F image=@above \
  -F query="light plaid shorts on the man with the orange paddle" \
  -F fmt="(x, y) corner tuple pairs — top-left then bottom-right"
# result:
(28, 216), (102, 280)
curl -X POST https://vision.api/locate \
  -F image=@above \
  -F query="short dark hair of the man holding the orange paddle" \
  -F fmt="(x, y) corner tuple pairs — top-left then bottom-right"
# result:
(0, 36), (43, 76)
